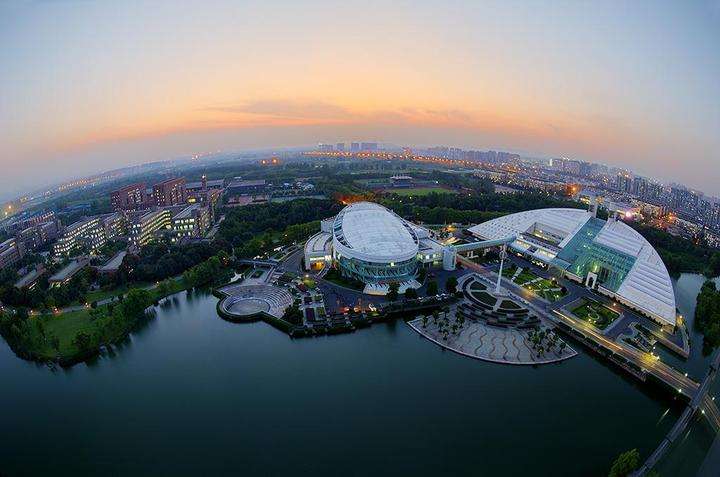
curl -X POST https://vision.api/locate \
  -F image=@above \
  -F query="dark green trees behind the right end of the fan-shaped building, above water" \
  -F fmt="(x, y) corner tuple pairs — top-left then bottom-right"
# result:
(632, 223), (720, 277)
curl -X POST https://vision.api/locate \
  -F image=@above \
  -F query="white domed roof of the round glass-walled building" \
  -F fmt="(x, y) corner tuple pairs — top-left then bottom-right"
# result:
(333, 202), (418, 263)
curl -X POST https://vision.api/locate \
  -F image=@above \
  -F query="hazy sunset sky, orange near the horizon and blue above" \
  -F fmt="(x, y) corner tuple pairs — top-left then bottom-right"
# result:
(0, 0), (720, 197)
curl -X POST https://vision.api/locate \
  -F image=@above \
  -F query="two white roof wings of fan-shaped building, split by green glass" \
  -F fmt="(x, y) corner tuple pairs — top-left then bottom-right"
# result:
(469, 209), (675, 325)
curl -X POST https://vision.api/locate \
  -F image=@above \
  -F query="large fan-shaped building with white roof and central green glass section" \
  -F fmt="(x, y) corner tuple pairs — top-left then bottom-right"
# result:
(469, 209), (676, 328)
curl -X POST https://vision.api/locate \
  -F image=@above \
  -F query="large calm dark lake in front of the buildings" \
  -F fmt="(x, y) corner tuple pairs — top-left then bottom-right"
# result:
(0, 278), (716, 476)
